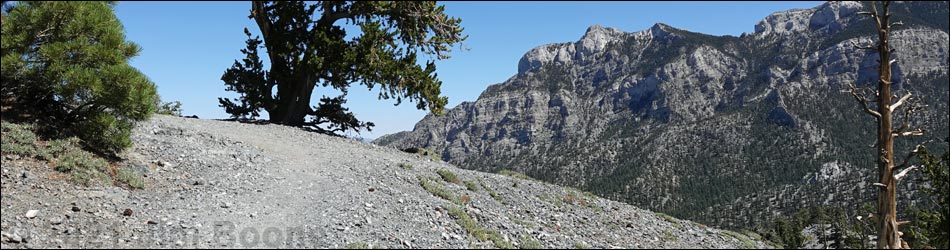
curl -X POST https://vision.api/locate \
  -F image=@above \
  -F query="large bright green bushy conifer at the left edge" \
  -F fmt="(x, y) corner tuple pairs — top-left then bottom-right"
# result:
(0, 2), (157, 153)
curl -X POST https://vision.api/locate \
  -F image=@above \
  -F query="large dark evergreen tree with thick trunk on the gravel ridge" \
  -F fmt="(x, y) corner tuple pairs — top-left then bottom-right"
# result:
(218, 1), (465, 133)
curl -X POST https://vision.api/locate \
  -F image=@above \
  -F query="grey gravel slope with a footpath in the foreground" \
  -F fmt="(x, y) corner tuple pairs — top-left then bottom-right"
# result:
(0, 116), (770, 249)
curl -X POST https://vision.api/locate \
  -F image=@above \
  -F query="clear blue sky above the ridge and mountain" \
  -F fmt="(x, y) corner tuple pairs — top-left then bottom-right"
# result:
(116, 1), (822, 139)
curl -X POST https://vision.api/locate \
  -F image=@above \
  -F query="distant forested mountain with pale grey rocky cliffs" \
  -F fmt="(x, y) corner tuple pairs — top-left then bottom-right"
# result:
(375, 2), (950, 230)
